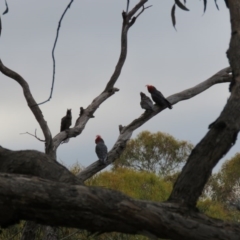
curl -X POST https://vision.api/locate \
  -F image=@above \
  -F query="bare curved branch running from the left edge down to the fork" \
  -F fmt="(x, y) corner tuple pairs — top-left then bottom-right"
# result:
(0, 60), (52, 156)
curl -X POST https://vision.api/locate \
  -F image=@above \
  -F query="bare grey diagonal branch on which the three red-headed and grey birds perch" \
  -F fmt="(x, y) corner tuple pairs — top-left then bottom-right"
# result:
(78, 67), (232, 181)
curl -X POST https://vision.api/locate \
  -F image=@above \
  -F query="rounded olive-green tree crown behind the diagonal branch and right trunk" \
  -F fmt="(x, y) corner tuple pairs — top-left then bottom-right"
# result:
(113, 131), (193, 176)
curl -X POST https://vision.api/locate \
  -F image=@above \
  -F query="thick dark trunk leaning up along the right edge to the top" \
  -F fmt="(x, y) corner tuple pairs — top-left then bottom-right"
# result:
(169, 0), (240, 207)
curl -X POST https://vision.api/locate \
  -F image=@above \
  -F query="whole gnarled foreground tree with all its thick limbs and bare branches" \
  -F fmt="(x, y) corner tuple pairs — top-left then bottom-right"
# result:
(0, 0), (240, 240)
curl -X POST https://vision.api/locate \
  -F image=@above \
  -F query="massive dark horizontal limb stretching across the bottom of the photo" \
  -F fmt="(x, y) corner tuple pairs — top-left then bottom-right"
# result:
(0, 173), (240, 240)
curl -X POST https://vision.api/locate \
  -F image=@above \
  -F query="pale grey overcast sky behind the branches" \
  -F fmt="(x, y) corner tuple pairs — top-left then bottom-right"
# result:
(0, 0), (232, 172)
